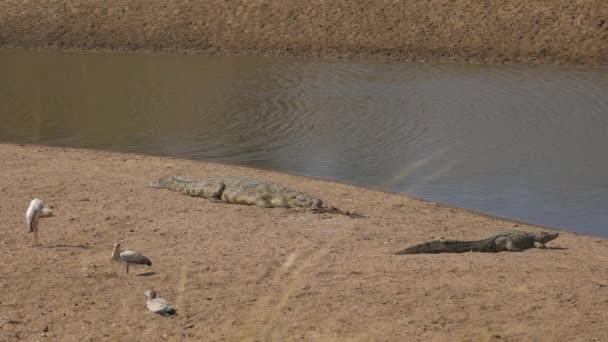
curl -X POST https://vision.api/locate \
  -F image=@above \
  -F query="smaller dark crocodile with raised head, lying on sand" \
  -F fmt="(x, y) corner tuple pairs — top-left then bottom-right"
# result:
(395, 230), (559, 254)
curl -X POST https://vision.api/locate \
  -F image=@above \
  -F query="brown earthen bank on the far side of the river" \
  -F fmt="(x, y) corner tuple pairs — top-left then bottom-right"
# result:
(0, 0), (608, 64)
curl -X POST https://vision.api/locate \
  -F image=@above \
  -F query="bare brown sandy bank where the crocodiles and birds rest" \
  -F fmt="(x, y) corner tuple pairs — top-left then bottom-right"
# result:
(0, 144), (608, 341)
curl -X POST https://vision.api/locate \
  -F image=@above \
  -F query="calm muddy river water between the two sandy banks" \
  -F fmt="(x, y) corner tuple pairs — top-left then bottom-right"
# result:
(0, 52), (608, 237)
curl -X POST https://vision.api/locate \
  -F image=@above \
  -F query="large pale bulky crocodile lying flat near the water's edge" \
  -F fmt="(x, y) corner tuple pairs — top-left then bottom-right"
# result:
(146, 176), (323, 209)
